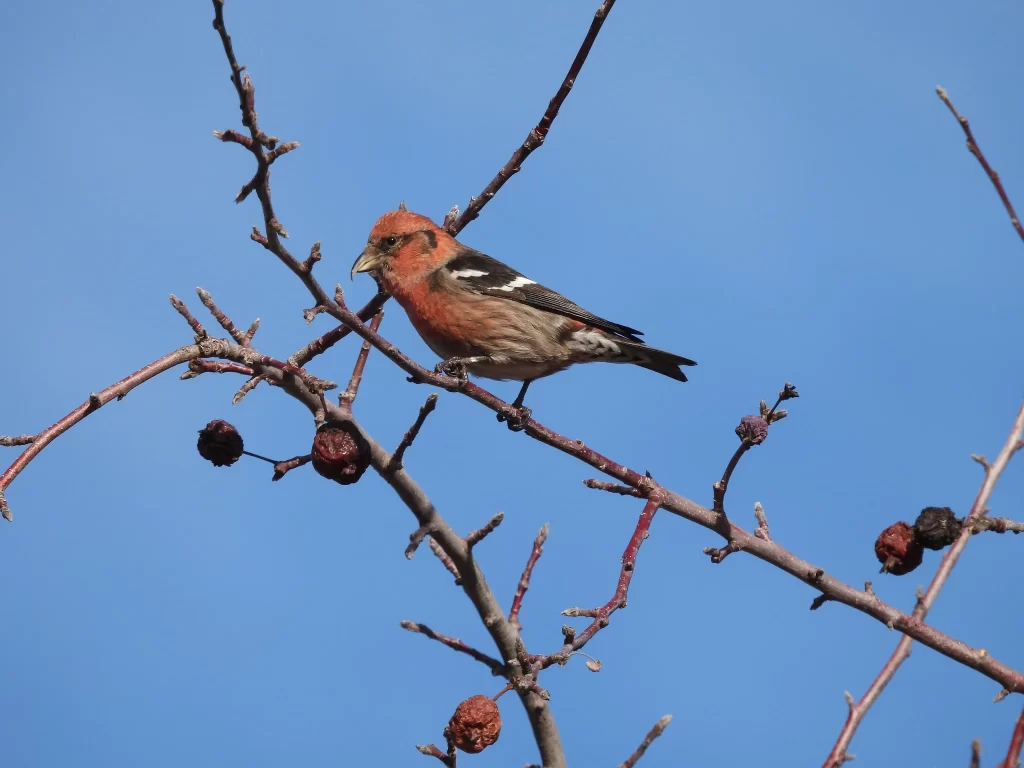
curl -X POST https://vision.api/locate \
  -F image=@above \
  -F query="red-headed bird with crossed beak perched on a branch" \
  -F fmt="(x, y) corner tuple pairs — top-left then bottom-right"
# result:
(351, 206), (696, 426)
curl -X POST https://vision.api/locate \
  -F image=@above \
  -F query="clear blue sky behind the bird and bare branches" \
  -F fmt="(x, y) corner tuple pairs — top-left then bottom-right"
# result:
(0, 0), (1024, 768)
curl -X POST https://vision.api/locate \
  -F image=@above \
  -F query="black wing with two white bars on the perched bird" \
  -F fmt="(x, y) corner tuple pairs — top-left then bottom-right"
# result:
(443, 248), (643, 344)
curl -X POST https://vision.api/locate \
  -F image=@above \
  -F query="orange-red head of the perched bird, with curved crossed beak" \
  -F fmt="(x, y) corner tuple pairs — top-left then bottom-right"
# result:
(352, 208), (453, 287)
